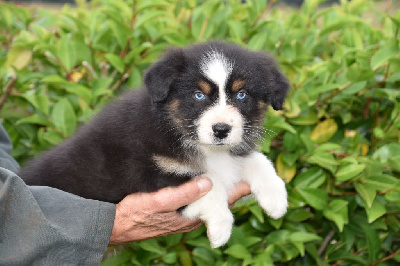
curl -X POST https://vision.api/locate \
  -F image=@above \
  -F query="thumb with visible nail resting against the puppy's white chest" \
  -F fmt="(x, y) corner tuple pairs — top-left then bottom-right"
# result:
(152, 177), (212, 212)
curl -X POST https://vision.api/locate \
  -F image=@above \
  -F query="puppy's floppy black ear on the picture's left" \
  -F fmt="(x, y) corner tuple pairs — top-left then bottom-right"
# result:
(144, 48), (184, 103)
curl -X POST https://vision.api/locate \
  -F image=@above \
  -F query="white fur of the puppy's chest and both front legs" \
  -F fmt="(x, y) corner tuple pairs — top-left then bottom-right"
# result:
(183, 148), (287, 248)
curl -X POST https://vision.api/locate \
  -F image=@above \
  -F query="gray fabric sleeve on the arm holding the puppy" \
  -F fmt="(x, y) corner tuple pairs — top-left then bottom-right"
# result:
(0, 124), (115, 265)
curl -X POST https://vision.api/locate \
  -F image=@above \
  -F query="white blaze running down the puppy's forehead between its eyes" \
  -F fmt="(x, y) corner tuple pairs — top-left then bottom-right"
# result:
(200, 50), (233, 105)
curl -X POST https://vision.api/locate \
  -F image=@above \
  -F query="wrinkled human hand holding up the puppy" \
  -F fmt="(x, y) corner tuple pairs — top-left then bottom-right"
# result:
(110, 178), (250, 245)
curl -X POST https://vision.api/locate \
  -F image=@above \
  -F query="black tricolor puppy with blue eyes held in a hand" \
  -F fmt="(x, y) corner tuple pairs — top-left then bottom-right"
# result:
(20, 42), (289, 247)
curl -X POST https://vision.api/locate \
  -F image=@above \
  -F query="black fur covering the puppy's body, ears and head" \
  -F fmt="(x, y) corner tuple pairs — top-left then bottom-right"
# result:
(19, 42), (289, 203)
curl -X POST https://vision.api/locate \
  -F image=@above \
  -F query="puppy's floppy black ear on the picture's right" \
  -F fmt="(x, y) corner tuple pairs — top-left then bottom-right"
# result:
(257, 53), (290, 110)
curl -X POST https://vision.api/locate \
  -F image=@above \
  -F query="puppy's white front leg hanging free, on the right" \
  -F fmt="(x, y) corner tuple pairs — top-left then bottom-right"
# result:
(243, 152), (288, 219)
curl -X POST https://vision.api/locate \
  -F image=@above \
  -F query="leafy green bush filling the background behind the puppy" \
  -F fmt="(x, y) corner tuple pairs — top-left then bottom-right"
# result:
(0, 0), (400, 265)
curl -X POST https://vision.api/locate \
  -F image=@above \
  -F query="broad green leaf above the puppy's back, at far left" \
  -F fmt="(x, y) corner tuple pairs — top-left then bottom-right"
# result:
(51, 98), (76, 137)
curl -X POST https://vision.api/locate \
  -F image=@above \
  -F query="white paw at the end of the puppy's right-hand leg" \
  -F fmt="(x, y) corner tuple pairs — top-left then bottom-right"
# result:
(257, 176), (288, 219)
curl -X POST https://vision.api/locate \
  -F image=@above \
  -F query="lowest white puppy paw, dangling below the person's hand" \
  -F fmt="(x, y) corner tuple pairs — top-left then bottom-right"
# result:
(207, 214), (233, 248)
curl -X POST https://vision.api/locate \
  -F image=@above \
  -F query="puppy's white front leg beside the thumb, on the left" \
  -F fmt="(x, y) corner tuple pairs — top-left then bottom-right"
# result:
(182, 179), (233, 248)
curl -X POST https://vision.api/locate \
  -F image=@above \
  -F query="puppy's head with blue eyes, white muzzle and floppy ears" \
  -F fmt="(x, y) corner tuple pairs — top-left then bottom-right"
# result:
(144, 42), (289, 152)
